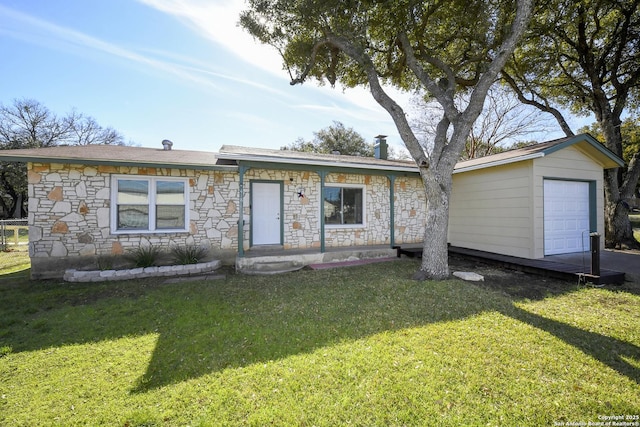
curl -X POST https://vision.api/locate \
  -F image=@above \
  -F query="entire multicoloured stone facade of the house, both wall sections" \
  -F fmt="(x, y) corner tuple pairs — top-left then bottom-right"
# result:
(28, 163), (426, 278)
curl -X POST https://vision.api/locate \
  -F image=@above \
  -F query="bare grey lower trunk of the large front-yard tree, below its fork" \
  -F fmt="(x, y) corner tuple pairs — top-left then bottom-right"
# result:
(413, 173), (452, 280)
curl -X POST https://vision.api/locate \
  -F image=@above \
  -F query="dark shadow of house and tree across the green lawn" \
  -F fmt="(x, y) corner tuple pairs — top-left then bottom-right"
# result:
(0, 261), (639, 393)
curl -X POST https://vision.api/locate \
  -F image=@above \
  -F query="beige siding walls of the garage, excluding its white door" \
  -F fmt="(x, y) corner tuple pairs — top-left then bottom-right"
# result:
(449, 146), (604, 258)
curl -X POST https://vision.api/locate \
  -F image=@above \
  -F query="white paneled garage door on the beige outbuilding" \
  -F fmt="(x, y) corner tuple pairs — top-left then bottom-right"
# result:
(544, 179), (590, 255)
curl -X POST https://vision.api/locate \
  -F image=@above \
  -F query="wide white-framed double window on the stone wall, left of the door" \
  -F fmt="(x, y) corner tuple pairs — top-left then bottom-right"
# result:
(111, 176), (188, 233)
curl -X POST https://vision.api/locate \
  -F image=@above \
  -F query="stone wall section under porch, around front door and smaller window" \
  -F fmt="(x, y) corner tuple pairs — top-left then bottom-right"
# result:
(244, 169), (426, 249)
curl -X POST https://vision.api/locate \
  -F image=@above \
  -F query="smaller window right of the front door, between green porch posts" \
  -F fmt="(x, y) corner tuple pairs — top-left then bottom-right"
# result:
(324, 187), (364, 225)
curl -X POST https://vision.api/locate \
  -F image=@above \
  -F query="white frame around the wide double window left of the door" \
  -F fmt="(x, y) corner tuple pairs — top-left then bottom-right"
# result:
(109, 175), (190, 234)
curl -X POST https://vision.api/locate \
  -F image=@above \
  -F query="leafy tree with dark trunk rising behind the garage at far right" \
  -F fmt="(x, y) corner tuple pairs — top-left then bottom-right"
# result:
(503, 0), (640, 248)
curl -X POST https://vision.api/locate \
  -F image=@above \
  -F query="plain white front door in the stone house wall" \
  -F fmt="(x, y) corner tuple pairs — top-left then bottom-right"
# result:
(251, 182), (282, 245)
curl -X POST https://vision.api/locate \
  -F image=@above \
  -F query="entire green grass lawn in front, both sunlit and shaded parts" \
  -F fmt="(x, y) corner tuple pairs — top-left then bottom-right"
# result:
(0, 261), (640, 426)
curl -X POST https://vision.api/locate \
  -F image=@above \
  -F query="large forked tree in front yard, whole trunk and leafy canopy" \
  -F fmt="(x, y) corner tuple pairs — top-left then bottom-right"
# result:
(240, 0), (533, 279)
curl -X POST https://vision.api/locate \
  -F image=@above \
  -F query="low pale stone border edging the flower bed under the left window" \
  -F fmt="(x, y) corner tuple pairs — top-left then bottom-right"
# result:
(63, 260), (222, 282)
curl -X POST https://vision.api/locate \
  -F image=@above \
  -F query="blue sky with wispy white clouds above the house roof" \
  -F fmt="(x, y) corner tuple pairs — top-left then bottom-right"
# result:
(0, 0), (576, 151)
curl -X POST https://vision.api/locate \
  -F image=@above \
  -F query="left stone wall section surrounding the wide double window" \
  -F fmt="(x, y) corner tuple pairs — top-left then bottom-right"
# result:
(28, 163), (239, 278)
